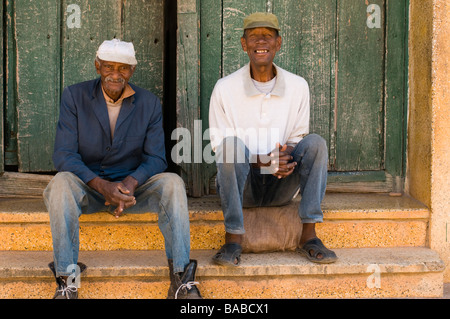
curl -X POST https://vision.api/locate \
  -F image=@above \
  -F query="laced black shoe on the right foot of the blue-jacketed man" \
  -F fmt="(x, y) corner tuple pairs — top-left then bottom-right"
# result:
(167, 259), (202, 299)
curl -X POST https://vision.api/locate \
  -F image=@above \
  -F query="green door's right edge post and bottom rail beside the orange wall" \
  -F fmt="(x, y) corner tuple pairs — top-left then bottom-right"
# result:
(327, 0), (409, 194)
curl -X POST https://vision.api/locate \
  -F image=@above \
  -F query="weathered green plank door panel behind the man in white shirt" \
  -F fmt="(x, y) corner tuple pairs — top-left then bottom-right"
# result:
(201, 0), (384, 171)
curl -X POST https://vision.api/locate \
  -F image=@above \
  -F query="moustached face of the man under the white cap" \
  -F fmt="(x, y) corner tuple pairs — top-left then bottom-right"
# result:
(95, 60), (134, 99)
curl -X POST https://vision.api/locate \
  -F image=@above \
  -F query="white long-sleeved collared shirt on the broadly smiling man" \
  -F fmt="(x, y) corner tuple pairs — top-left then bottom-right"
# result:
(209, 64), (310, 154)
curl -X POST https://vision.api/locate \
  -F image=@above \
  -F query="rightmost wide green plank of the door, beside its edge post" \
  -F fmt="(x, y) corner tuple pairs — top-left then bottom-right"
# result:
(335, 0), (384, 171)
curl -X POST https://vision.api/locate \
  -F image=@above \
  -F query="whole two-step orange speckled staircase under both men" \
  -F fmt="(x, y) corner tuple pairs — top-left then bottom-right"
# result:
(0, 193), (444, 299)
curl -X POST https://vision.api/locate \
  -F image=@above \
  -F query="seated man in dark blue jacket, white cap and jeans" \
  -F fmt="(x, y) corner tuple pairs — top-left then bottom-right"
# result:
(44, 39), (201, 299)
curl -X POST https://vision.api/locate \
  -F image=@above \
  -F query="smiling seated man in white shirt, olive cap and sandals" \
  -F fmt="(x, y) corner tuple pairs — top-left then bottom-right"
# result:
(209, 13), (337, 266)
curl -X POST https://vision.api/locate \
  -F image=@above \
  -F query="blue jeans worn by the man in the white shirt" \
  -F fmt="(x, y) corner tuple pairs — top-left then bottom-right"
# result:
(216, 134), (328, 234)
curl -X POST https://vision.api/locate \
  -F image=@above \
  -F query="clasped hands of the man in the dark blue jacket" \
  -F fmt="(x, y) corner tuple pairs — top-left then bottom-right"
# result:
(88, 176), (138, 218)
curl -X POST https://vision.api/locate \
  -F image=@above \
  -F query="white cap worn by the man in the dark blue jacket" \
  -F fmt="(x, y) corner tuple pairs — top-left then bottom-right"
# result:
(97, 39), (137, 65)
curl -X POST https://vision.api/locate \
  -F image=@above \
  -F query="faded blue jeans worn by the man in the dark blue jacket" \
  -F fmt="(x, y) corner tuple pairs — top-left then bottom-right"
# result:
(44, 172), (190, 276)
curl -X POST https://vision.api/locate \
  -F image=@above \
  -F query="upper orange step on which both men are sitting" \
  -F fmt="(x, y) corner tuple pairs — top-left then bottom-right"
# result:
(0, 193), (430, 252)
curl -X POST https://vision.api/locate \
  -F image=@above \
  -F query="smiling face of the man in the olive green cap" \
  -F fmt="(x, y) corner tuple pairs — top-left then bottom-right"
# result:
(241, 28), (281, 66)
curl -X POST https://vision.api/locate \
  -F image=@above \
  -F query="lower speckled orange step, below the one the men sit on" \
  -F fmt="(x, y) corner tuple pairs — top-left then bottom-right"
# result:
(0, 247), (444, 299)
